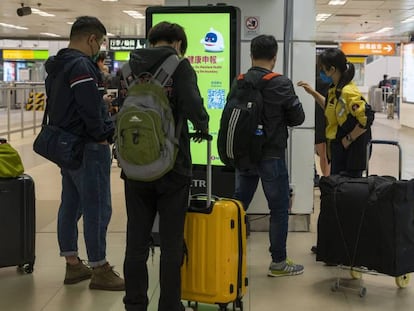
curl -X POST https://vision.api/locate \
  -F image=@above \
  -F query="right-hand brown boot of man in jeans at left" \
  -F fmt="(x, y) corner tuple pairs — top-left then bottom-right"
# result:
(89, 263), (125, 291)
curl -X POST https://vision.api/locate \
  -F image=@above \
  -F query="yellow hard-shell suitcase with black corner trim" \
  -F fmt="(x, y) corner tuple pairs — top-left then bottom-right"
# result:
(181, 197), (248, 310)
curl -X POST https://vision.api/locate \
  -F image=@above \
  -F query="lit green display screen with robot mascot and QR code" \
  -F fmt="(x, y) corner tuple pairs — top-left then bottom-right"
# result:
(152, 12), (236, 165)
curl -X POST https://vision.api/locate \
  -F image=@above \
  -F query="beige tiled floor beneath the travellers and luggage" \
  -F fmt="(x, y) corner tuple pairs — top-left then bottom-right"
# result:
(0, 114), (414, 311)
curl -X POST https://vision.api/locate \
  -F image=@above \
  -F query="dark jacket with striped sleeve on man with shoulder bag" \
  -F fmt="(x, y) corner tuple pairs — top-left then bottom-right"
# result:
(45, 48), (115, 142)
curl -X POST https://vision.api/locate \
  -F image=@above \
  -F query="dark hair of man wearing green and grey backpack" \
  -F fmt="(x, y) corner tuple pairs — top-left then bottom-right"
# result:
(148, 22), (188, 55)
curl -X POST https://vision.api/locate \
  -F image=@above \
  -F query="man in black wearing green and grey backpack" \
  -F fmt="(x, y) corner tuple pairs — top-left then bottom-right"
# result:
(116, 22), (209, 311)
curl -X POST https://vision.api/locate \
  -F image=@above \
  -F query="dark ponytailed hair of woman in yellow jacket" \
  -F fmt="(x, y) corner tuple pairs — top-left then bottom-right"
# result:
(319, 48), (355, 93)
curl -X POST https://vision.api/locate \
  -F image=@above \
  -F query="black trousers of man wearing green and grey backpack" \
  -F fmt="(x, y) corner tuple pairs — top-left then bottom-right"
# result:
(124, 172), (191, 311)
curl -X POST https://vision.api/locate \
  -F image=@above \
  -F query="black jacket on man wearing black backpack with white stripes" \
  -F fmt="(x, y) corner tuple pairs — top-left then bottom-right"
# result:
(229, 67), (305, 159)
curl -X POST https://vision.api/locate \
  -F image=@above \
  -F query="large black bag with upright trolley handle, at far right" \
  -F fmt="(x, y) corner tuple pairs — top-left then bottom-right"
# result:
(316, 140), (414, 278)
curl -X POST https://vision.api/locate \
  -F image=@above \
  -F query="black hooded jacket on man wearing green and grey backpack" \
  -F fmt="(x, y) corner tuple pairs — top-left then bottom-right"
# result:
(129, 46), (209, 176)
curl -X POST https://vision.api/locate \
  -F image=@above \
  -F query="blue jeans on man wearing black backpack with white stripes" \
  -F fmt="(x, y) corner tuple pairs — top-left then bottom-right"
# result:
(234, 158), (289, 262)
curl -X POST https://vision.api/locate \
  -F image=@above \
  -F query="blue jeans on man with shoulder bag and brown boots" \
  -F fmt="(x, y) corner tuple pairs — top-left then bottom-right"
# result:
(57, 143), (112, 267)
